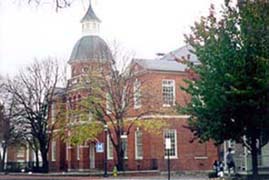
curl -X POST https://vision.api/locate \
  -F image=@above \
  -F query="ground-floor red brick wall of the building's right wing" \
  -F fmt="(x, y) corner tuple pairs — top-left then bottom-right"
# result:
(120, 119), (217, 170)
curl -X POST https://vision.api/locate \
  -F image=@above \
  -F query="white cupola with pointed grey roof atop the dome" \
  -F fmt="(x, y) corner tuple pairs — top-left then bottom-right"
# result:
(80, 1), (101, 36)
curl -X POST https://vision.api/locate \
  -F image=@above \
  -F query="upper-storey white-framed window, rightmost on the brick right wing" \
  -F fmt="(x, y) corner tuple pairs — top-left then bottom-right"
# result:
(162, 80), (176, 107)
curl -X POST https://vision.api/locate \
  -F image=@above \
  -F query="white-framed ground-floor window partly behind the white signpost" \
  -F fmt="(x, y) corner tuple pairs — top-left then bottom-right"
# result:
(164, 129), (177, 158)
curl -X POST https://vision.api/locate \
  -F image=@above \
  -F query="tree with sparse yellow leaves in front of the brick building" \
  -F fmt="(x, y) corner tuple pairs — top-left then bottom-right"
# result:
(63, 47), (168, 170)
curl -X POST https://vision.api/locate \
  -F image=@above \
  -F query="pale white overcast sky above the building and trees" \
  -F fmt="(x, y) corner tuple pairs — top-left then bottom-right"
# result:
(0, 0), (223, 76)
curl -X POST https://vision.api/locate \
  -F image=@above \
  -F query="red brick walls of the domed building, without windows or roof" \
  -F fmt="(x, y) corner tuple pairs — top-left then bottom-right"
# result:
(46, 64), (217, 171)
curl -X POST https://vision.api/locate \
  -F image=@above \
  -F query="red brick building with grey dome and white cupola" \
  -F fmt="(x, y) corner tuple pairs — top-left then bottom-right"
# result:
(46, 2), (217, 171)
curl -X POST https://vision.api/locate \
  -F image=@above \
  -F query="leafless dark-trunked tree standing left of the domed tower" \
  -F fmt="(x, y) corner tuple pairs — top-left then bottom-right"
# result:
(5, 58), (62, 172)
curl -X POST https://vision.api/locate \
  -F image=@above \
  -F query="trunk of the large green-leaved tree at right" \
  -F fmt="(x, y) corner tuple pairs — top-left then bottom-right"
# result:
(251, 135), (259, 180)
